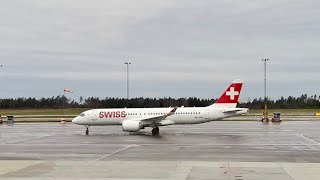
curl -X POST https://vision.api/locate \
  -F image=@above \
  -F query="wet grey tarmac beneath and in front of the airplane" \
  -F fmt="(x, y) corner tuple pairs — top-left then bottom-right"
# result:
(0, 121), (320, 180)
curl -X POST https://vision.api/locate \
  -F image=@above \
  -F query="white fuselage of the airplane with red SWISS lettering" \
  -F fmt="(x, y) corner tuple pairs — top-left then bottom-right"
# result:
(72, 107), (248, 126)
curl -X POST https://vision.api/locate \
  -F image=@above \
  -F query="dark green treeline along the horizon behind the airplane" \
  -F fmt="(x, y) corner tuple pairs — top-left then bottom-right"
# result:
(0, 94), (320, 109)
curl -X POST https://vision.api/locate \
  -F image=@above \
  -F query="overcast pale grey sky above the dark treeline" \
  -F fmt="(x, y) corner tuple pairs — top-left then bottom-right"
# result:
(0, 0), (320, 102)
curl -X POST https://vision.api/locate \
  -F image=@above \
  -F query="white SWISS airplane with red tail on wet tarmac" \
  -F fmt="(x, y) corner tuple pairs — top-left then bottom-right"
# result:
(72, 79), (249, 135)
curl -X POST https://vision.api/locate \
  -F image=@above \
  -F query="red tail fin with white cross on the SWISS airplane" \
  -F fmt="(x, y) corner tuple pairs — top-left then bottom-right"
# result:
(212, 79), (243, 108)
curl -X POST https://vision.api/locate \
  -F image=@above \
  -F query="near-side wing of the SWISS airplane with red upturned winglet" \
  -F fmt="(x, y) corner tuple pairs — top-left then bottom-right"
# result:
(122, 107), (177, 126)
